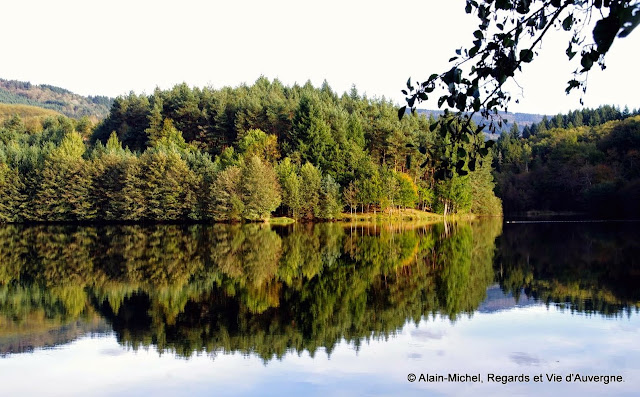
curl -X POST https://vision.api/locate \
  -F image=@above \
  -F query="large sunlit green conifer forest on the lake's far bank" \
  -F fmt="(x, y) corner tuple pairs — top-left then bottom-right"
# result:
(0, 78), (501, 222)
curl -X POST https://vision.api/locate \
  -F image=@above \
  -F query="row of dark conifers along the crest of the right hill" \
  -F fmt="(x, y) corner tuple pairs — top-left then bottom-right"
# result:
(522, 105), (640, 138)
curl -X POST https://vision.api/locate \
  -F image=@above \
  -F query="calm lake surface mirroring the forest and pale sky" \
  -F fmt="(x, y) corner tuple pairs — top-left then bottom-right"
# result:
(0, 220), (640, 396)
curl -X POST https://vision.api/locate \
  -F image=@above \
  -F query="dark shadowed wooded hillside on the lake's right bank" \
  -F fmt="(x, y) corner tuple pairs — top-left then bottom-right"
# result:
(494, 108), (640, 217)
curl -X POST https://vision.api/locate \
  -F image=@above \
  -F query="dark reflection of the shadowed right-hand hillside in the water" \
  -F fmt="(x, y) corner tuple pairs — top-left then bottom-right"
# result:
(495, 223), (640, 315)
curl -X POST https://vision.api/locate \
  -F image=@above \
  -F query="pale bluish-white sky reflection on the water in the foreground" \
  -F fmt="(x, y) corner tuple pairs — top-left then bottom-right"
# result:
(0, 305), (640, 396)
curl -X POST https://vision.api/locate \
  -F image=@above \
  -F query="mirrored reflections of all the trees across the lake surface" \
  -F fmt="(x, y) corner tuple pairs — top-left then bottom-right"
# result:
(0, 220), (638, 360)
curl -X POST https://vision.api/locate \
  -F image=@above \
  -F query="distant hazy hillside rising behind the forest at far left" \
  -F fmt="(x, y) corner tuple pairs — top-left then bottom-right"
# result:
(0, 79), (113, 119)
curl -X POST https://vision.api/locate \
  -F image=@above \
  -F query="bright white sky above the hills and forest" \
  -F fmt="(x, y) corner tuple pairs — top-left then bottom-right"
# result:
(0, 0), (640, 114)
